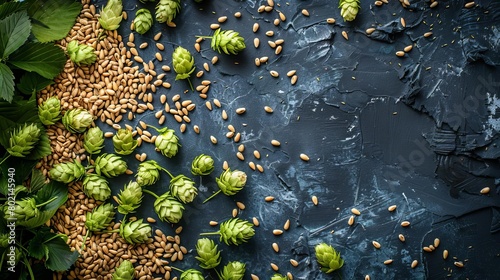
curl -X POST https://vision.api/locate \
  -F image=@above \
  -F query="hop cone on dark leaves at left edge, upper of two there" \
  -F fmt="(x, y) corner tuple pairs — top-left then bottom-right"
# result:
(7, 123), (42, 157)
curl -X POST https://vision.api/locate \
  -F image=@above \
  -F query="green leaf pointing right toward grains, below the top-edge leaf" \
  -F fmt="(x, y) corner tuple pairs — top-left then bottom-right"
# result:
(8, 42), (66, 79)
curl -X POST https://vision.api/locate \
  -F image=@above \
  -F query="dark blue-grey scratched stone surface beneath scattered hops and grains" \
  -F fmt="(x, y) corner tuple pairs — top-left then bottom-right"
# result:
(97, 0), (500, 279)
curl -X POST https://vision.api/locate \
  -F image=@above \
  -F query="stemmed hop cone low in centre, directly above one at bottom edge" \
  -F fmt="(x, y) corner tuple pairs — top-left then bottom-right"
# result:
(218, 218), (255, 245)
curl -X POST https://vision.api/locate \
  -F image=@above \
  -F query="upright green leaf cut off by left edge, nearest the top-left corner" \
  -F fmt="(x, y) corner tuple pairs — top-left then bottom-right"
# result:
(0, 11), (31, 59)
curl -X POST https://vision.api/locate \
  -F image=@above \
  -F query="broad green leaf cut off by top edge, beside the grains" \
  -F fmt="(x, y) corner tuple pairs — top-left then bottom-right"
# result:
(28, 0), (82, 43)
